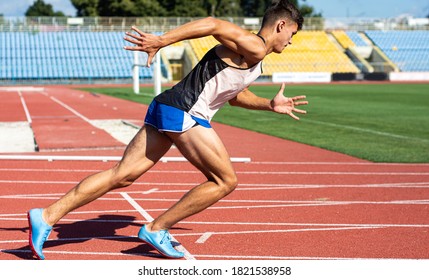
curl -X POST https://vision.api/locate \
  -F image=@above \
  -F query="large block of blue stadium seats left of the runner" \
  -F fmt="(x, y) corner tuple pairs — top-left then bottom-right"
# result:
(0, 32), (157, 80)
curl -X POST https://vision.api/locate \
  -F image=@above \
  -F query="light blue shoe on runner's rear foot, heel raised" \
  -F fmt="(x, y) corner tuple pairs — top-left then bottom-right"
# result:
(27, 208), (52, 260)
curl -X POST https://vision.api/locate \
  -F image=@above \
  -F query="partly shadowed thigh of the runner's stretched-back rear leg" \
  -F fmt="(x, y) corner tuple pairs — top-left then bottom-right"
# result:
(118, 125), (172, 176)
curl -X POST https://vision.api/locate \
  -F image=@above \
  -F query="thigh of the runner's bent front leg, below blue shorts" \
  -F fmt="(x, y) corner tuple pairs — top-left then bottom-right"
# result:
(167, 125), (235, 182)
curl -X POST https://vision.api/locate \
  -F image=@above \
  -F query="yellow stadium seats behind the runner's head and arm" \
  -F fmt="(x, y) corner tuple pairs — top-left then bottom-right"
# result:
(190, 31), (359, 76)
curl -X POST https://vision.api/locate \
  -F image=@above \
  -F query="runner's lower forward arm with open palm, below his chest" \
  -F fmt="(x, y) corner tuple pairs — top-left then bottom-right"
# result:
(229, 84), (308, 120)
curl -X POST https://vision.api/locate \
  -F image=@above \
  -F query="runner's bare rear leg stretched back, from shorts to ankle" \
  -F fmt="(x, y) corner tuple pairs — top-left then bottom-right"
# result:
(43, 125), (172, 225)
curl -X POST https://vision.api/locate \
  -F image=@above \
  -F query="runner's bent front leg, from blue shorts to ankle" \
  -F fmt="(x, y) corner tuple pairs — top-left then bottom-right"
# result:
(147, 126), (237, 231)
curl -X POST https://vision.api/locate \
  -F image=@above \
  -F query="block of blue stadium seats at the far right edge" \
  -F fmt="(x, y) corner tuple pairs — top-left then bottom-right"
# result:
(366, 30), (429, 72)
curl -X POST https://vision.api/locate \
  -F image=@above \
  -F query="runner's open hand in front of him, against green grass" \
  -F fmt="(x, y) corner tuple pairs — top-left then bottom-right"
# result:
(271, 83), (308, 120)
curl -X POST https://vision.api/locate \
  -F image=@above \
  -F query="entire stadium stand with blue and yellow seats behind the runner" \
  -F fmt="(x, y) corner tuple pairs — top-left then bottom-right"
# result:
(0, 17), (429, 84)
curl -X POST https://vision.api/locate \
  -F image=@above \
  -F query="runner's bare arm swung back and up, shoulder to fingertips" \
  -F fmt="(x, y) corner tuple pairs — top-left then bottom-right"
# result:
(124, 17), (267, 65)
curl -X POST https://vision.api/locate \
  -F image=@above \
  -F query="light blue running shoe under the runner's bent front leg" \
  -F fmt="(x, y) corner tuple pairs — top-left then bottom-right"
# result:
(138, 225), (185, 259)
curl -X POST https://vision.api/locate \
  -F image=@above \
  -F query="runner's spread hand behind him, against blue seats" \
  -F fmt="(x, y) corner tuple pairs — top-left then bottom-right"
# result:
(124, 26), (163, 67)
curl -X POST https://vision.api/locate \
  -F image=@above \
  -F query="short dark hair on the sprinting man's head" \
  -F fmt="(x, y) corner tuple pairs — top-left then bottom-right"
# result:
(262, 0), (304, 30)
